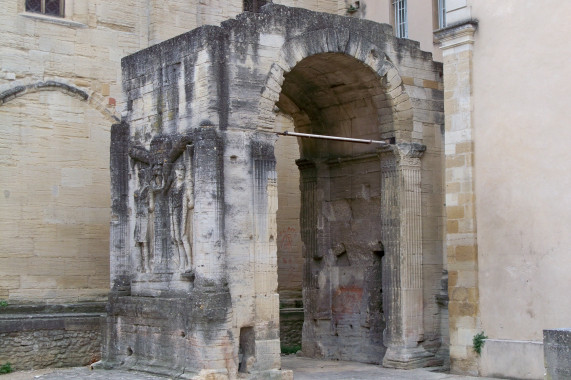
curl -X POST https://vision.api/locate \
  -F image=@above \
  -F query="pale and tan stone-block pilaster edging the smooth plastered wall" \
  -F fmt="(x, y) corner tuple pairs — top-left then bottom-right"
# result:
(437, 18), (480, 375)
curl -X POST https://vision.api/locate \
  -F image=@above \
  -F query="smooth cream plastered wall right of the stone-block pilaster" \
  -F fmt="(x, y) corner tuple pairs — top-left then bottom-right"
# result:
(469, 0), (571, 378)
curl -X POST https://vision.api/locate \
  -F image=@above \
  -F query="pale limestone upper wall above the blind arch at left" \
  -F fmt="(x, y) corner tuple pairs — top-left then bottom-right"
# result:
(0, 0), (147, 99)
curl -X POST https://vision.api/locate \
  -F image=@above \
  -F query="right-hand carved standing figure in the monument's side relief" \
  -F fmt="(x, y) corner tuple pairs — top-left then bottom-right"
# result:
(168, 162), (194, 272)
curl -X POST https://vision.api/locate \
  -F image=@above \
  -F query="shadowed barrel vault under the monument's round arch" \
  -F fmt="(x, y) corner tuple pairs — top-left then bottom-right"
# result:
(277, 53), (394, 159)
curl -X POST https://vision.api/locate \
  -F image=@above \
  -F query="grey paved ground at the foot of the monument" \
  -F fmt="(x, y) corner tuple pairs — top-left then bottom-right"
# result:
(0, 355), (498, 380)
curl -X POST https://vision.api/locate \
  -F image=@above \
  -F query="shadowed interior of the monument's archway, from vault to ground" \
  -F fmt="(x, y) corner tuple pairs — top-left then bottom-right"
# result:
(276, 53), (394, 363)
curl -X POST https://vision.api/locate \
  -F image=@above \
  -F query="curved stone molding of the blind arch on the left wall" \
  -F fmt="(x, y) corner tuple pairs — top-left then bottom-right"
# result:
(0, 80), (120, 123)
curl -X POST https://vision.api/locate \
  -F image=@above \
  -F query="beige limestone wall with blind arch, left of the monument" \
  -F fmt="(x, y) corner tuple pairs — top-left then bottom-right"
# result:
(0, 0), (147, 304)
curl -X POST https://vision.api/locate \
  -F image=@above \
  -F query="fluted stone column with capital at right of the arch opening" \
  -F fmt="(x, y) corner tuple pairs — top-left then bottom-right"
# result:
(380, 144), (432, 368)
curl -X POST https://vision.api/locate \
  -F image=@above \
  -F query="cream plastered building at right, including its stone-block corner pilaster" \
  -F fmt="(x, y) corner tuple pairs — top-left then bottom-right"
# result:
(436, 1), (571, 379)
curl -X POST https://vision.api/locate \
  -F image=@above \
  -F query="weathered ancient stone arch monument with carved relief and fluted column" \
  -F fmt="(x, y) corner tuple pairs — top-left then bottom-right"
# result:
(104, 4), (442, 379)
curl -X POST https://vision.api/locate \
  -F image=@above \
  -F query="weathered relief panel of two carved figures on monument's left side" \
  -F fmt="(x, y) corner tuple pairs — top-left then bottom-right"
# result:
(129, 136), (194, 274)
